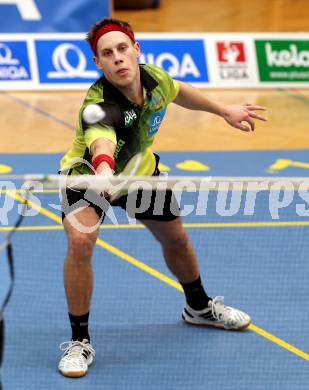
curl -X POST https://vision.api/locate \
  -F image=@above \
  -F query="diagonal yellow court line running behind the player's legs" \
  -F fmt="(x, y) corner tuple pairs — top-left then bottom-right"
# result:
(8, 191), (309, 361)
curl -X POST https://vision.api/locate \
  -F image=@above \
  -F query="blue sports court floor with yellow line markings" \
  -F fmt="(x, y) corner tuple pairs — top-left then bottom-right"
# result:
(0, 150), (309, 390)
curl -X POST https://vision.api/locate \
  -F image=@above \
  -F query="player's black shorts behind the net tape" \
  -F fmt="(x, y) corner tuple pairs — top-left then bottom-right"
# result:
(61, 155), (180, 222)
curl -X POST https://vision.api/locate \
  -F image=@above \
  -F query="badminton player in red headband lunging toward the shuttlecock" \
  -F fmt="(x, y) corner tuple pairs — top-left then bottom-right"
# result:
(58, 19), (265, 377)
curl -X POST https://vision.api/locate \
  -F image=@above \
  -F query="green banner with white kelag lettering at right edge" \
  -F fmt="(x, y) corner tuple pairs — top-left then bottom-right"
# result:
(255, 39), (309, 82)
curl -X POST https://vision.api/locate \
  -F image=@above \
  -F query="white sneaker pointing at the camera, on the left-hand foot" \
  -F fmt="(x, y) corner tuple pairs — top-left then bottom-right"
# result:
(58, 339), (95, 378)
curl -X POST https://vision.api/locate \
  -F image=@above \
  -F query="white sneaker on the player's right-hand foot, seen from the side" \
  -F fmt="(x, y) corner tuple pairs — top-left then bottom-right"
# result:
(182, 297), (251, 330)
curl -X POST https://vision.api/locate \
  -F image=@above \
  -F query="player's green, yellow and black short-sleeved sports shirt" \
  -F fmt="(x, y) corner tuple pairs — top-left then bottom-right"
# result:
(60, 65), (179, 176)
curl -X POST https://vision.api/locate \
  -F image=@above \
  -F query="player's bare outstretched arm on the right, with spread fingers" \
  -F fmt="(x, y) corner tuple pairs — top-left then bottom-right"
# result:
(173, 81), (266, 131)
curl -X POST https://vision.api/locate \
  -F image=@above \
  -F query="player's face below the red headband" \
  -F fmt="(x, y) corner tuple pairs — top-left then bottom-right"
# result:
(94, 31), (140, 88)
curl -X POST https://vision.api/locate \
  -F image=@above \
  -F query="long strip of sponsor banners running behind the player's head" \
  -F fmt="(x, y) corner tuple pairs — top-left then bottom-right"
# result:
(0, 32), (309, 90)
